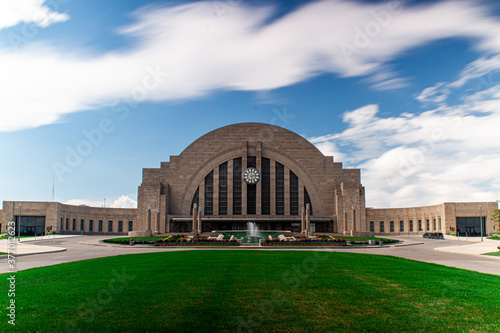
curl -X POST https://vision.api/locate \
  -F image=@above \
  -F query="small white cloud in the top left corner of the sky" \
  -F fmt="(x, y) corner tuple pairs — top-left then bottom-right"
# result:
(0, 0), (69, 30)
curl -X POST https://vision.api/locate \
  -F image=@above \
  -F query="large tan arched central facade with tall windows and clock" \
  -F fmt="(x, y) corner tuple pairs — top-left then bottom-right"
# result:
(138, 123), (366, 233)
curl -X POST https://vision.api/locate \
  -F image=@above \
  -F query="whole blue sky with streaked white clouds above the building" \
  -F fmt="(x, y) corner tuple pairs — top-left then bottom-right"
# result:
(0, 0), (500, 207)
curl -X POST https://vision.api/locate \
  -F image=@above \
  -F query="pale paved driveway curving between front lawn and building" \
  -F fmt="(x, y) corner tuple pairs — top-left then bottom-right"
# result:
(0, 236), (500, 275)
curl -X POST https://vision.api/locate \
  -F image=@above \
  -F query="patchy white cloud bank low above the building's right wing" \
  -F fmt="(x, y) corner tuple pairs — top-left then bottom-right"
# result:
(310, 85), (500, 207)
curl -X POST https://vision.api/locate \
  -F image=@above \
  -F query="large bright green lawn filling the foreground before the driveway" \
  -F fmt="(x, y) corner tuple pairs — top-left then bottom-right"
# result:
(0, 250), (500, 332)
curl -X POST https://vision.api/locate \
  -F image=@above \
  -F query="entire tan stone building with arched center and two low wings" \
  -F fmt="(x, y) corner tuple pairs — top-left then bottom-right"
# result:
(0, 123), (498, 236)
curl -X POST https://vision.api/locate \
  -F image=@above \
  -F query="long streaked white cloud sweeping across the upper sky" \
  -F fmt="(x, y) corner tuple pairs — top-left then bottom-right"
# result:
(0, 0), (500, 132)
